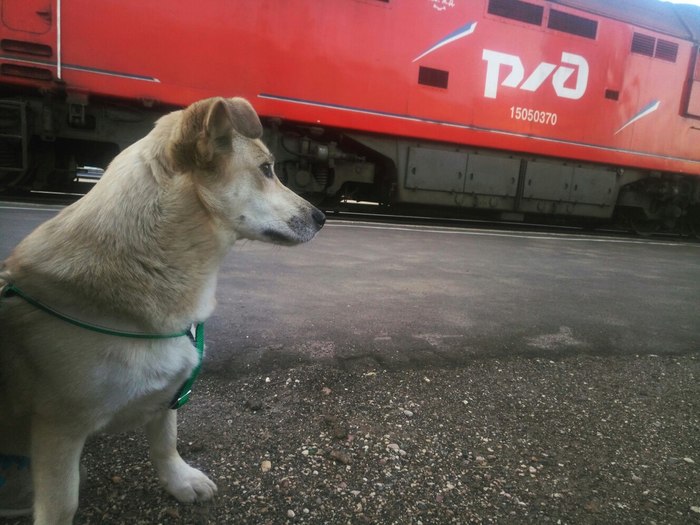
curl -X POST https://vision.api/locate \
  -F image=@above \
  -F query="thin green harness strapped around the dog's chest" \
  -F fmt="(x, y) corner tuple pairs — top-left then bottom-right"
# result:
(0, 284), (204, 410)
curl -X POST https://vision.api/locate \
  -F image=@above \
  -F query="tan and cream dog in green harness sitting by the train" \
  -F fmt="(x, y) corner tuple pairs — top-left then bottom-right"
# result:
(0, 98), (325, 525)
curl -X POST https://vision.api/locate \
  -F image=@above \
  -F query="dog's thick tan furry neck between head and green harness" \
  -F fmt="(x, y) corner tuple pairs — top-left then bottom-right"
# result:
(6, 145), (235, 332)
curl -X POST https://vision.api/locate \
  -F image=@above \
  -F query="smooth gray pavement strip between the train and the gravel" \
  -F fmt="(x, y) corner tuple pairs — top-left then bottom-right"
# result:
(5, 204), (700, 368)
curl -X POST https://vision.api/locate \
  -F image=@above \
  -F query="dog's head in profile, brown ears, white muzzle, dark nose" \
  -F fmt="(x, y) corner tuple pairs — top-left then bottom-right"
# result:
(167, 98), (325, 244)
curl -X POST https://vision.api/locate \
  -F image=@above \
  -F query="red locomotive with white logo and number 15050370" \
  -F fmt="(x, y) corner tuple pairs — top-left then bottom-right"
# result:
(0, 0), (700, 235)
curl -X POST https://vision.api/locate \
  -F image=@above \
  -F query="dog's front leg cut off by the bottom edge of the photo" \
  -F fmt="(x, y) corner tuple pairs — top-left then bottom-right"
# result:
(31, 416), (87, 525)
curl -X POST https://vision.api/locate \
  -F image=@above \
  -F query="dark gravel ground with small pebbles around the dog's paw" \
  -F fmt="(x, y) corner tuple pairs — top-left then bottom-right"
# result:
(0, 354), (700, 525)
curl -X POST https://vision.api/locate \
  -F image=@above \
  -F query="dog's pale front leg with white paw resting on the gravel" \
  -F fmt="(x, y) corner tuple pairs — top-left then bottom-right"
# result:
(146, 409), (216, 503)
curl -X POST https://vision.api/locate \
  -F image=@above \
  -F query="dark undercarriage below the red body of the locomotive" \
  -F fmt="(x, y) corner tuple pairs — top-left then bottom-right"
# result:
(0, 95), (700, 237)
